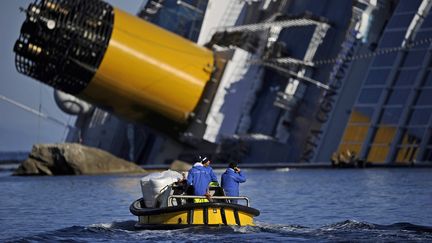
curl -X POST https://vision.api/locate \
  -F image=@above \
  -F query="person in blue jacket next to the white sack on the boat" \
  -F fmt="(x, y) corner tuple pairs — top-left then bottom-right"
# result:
(187, 156), (218, 202)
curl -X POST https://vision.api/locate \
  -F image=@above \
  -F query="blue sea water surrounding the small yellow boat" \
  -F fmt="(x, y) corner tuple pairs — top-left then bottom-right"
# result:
(0, 168), (432, 242)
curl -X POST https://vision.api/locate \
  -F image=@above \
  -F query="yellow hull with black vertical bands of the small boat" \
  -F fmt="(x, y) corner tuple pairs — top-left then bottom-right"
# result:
(130, 199), (259, 229)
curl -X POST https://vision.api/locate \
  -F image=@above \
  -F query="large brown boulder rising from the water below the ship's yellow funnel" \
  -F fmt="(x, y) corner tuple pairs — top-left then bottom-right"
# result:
(14, 143), (145, 175)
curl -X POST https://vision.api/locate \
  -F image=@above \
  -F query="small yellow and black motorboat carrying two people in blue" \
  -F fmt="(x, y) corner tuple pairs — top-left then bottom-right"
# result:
(130, 184), (260, 229)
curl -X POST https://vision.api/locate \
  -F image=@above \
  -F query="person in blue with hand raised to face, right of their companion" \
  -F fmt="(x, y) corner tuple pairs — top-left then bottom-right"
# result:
(221, 162), (246, 203)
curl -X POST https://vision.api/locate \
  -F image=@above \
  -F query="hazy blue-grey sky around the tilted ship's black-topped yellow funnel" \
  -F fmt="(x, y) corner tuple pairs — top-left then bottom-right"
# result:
(0, 0), (146, 152)
